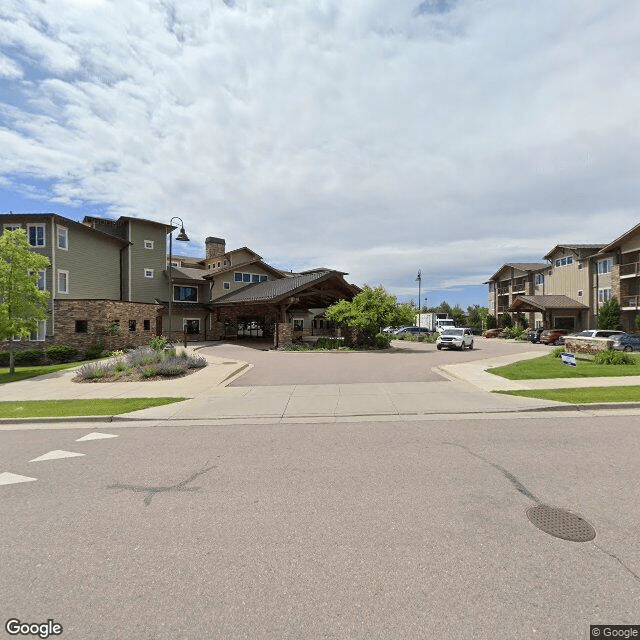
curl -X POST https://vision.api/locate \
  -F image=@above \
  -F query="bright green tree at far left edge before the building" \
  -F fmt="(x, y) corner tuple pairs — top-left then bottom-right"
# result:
(0, 229), (49, 374)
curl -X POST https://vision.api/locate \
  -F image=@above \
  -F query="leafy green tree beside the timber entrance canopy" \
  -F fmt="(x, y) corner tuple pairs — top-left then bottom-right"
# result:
(325, 286), (415, 344)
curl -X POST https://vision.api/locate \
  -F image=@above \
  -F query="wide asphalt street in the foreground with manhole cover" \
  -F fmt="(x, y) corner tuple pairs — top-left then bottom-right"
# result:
(0, 414), (640, 640)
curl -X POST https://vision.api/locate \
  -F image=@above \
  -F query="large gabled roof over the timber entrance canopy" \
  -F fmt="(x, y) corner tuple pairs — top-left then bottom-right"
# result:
(210, 269), (357, 306)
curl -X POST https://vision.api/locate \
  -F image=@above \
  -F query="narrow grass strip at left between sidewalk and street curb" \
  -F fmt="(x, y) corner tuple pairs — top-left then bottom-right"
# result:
(0, 398), (185, 418)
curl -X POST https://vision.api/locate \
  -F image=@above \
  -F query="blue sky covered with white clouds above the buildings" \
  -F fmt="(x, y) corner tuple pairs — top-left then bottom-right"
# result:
(0, 0), (640, 308)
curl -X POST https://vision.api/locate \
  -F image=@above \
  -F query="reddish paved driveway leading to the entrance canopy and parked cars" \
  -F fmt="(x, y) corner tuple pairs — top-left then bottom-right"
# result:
(201, 337), (552, 387)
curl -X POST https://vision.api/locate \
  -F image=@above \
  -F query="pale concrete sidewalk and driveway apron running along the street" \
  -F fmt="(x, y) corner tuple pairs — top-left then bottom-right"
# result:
(0, 344), (640, 424)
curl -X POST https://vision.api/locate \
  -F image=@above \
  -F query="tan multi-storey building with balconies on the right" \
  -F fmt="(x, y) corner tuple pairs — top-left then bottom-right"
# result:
(487, 224), (640, 332)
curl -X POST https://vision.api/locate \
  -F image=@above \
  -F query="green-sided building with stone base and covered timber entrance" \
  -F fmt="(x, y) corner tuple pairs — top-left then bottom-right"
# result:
(0, 213), (359, 348)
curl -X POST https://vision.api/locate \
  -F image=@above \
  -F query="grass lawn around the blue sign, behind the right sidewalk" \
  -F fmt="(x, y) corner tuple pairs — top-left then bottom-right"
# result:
(487, 354), (640, 380)
